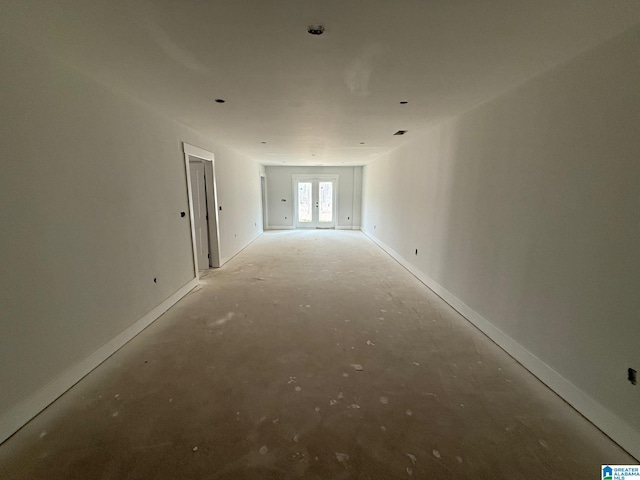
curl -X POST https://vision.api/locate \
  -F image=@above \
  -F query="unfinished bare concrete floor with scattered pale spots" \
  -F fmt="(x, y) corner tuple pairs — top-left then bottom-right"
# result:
(0, 231), (636, 480)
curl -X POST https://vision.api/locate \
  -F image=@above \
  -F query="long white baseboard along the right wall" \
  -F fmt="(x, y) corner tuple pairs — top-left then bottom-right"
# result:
(362, 230), (640, 461)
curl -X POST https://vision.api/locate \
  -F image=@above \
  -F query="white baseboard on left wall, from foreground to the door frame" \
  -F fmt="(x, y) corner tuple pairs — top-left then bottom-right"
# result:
(0, 278), (198, 444)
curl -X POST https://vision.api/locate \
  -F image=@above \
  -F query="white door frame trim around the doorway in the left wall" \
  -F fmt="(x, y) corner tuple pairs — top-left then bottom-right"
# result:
(182, 142), (220, 278)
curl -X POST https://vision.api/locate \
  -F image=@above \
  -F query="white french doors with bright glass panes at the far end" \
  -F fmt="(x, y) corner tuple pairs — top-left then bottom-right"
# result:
(293, 176), (337, 228)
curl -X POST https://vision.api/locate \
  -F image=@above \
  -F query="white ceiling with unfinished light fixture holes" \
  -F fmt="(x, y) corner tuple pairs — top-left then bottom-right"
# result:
(0, 0), (640, 165)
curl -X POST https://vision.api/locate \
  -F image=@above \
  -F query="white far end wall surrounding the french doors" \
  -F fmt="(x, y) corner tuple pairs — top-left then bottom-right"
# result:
(266, 166), (362, 229)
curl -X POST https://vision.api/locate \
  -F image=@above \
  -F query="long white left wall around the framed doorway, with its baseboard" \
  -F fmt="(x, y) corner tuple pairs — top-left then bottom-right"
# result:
(0, 30), (262, 441)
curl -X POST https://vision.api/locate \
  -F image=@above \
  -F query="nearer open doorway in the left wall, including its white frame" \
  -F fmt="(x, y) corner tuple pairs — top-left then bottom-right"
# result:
(183, 143), (220, 276)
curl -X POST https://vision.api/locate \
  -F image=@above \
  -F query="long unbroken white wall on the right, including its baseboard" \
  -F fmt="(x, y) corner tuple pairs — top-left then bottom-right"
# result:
(363, 25), (640, 458)
